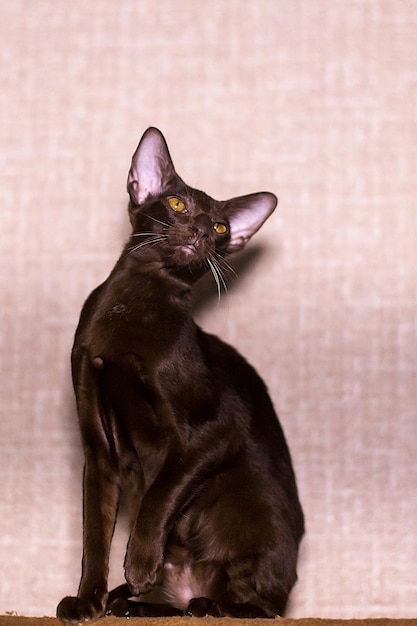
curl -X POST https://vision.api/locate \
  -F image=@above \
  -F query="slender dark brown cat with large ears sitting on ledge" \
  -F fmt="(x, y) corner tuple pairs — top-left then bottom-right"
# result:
(57, 128), (304, 623)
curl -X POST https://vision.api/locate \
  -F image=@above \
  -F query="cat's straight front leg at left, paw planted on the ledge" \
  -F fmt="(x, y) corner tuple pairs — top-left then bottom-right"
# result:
(57, 347), (120, 624)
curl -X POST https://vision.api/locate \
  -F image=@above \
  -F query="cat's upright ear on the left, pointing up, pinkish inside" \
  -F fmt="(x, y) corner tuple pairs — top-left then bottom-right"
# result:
(127, 127), (176, 204)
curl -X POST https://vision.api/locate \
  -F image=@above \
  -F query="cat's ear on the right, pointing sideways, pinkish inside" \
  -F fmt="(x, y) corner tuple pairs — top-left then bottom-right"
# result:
(224, 191), (278, 253)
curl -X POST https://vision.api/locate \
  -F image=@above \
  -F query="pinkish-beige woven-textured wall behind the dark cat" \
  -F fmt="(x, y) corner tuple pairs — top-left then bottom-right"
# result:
(0, 0), (417, 617)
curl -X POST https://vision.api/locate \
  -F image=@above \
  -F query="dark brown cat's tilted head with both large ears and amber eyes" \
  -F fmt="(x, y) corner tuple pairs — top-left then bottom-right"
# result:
(127, 128), (277, 280)
